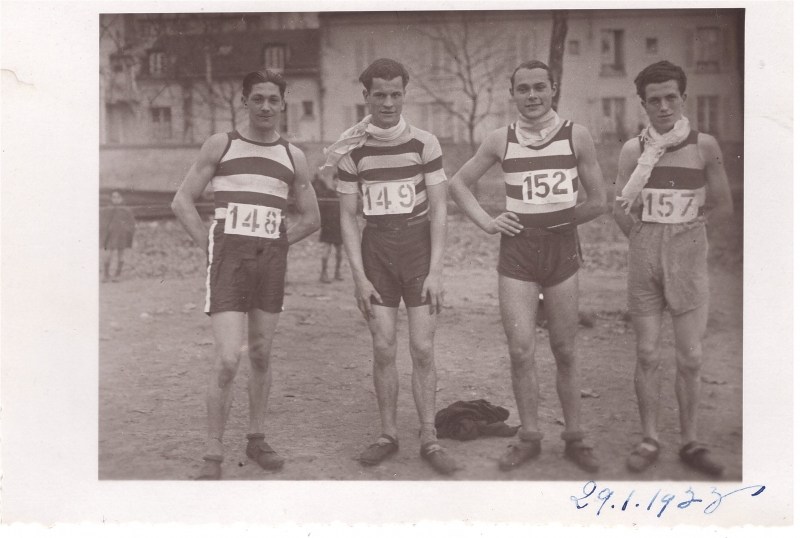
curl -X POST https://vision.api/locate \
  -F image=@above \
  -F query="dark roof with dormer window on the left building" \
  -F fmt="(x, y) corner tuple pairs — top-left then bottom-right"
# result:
(142, 29), (320, 78)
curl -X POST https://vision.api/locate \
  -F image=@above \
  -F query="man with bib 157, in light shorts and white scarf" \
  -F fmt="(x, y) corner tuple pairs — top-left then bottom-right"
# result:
(614, 61), (733, 475)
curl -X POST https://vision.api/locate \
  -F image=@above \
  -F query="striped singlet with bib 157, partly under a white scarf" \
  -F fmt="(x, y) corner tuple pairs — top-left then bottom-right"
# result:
(637, 131), (708, 224)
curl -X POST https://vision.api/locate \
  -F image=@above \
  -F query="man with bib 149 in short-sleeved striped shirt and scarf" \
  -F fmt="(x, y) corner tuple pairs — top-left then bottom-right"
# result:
(327, 58), (457, 474)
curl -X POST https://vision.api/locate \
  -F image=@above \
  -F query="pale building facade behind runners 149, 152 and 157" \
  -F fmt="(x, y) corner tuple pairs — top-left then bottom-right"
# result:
(319, 9), (744, 143)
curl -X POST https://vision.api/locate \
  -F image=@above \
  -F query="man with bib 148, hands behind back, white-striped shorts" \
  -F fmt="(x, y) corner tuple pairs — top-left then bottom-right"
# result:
(172, 71), (319, 480)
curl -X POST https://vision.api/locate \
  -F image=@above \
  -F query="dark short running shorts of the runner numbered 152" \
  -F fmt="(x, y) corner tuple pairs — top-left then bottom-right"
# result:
(497, 228), (581, 288)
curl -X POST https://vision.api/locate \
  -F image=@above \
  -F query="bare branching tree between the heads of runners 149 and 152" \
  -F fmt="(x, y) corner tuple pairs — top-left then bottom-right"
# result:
(412, 14), (514, 153)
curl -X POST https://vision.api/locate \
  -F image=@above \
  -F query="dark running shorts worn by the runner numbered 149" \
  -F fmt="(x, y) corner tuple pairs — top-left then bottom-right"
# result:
(361, 220), (431, 308)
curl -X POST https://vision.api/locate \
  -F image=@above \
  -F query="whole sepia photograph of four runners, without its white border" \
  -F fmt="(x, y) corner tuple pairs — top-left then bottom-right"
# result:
(98, 9), (746, 482)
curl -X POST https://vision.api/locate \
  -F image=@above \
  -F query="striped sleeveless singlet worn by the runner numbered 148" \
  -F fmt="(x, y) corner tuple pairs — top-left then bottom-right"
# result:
(211, 131), (295, 235)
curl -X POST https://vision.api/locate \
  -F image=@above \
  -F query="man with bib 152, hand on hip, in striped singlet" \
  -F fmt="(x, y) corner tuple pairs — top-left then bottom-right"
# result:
(450, 61), (605, 471)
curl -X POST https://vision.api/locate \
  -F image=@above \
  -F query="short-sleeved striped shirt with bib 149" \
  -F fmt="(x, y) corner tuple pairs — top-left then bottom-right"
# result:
(337, 125), (447, 222)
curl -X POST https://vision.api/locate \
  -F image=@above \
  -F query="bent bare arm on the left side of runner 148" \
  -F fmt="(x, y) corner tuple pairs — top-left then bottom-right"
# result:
(171, 133), (228, 250)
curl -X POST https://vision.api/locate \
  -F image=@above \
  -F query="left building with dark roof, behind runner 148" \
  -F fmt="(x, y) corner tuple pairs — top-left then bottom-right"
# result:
(100, 13), (321, 146)
